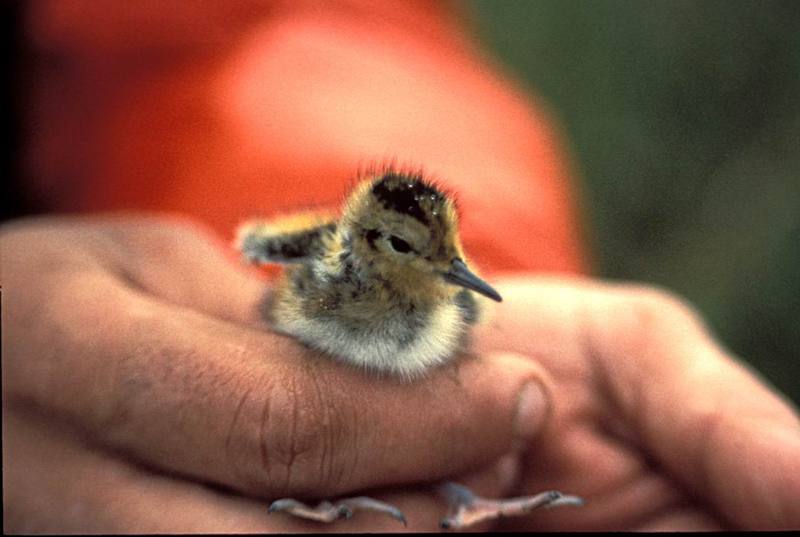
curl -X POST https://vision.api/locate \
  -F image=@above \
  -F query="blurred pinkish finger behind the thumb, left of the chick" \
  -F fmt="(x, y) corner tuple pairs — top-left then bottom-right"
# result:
(37, 215), (267, 324)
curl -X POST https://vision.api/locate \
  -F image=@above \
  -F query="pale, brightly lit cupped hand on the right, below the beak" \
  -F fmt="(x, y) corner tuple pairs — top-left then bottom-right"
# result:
(476, 278), (800, 531)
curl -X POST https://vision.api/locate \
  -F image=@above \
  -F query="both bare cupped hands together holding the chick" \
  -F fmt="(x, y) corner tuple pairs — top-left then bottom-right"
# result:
(0, 215), (800, 533)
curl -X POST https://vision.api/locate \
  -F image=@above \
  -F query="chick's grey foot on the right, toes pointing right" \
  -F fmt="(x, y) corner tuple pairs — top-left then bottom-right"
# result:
(439, 482), (584, 529)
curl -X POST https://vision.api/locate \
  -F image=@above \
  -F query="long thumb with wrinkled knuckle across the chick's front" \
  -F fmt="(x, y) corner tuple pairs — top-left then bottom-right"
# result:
(4, 266), (547, 498)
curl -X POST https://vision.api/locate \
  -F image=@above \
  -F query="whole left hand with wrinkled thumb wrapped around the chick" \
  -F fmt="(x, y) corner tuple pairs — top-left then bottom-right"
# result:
(0, 217), (546, 533)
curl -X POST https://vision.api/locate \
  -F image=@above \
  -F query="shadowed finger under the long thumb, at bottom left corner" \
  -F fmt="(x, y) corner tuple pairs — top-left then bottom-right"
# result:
(3, 406), (456, 534)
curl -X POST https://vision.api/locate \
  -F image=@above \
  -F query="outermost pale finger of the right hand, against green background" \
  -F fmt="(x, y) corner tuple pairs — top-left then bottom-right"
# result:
(588, 282), (800, 529)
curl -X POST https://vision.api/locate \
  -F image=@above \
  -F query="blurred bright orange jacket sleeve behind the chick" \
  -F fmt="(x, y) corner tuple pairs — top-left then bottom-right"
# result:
(26, 0), (582, 272)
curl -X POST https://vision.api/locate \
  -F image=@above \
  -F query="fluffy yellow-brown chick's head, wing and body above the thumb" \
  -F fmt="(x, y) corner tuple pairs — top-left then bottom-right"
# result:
(238, 172), (501, 379)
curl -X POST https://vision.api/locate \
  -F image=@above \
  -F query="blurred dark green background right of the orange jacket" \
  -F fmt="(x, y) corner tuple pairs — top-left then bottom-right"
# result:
(467, 0), (800, 404)
